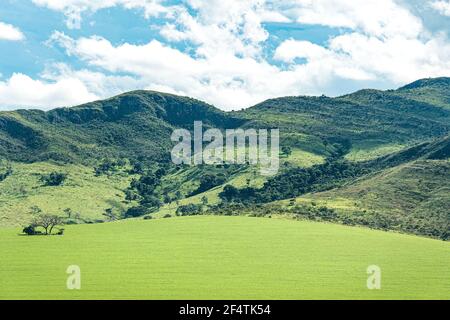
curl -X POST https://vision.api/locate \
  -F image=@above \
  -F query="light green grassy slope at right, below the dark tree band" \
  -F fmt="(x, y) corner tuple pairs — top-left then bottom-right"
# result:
(286, 160), (450, 238)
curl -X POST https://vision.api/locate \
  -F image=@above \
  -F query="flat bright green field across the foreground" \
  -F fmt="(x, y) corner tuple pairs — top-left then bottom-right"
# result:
(0, 216), (450, 299)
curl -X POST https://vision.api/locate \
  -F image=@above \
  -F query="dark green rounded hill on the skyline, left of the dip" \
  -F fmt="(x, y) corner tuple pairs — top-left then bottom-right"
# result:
(0, 91), (240, 164)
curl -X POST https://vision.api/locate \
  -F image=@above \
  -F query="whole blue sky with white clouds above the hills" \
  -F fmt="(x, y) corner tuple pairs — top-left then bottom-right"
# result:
(0, 0), (450, 110)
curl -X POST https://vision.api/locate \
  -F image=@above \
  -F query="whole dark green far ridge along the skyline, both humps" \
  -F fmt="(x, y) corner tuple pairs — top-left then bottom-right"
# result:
(0, 79), (450, 163)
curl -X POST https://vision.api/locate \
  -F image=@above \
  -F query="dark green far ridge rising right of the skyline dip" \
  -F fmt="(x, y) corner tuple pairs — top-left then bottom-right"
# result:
(239, 83), (450, 157)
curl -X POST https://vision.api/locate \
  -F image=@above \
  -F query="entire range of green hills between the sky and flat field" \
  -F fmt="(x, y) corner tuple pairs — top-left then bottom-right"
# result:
(0, 78), (450, 240)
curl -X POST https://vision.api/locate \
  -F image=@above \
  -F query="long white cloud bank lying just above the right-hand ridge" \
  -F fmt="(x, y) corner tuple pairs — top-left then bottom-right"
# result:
(275, 33), (450, 85)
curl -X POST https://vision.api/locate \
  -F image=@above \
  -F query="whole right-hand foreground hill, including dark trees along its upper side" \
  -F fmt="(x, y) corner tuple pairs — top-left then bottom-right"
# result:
(216, 137), (450, 240)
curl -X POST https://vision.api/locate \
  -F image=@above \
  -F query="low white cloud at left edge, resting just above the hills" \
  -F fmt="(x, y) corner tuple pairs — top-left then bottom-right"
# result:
(0, 73), (97, 110)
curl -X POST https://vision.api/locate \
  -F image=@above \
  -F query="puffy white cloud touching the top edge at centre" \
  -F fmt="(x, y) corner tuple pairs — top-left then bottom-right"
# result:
(160, 0), (270, 57)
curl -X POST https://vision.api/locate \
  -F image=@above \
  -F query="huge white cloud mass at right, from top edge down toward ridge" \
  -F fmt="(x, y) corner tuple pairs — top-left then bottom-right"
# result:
(274, 0), (450, 84)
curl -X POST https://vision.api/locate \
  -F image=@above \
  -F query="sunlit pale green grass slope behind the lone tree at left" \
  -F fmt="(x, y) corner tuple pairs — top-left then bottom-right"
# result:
(0, 162), (132, 227)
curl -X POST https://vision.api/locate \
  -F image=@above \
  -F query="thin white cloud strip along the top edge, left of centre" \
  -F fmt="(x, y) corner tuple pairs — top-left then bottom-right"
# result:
(32, 0), (168, 29)
